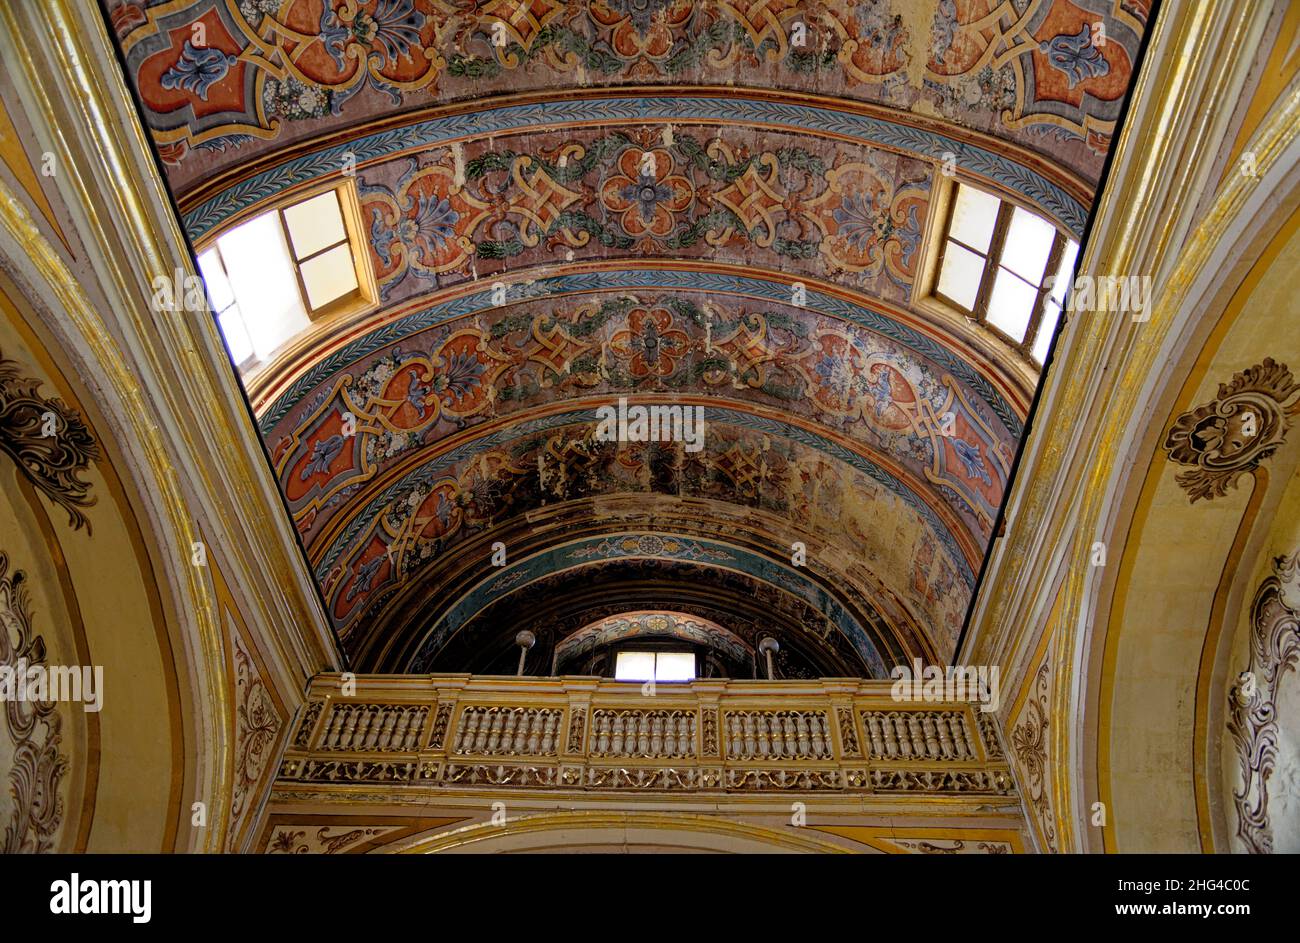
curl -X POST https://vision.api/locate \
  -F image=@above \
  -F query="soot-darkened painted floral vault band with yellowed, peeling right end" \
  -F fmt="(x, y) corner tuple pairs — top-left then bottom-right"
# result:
(324, 421), (969, 644)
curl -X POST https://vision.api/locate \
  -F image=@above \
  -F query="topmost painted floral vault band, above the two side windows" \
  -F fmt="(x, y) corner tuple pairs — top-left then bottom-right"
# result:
(109, 0), (1145, 179)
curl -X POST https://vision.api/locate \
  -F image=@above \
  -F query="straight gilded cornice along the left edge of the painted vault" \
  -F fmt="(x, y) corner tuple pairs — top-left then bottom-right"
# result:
(0, 0), (338, 687)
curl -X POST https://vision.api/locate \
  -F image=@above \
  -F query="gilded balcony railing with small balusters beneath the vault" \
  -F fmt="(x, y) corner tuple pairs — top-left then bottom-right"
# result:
(280, 675), (1014, 796)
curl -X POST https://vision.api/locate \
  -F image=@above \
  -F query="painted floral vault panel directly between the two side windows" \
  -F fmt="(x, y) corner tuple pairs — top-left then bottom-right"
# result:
(345, 127), (933, 303)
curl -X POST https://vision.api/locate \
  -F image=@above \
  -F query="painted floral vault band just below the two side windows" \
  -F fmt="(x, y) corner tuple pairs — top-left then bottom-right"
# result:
(270, 294), (1014, 577)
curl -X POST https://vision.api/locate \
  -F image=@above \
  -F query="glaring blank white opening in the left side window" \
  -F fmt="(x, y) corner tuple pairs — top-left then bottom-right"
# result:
(217, 212), (311, 360)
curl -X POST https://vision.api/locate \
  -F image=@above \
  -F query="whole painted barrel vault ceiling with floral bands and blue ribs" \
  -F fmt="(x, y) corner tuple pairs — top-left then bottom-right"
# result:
(104, 0), (1149, 676)
